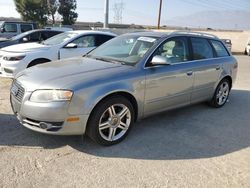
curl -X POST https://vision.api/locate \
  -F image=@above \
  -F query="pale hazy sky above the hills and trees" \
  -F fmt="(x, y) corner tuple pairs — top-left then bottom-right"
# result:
(0, 0), (250, 28)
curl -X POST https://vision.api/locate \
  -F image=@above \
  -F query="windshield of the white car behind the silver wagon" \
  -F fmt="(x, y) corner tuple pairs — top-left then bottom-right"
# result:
(43, 32), (78, 45)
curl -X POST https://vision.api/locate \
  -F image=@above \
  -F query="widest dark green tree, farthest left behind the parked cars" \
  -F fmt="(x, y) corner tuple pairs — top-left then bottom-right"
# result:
(14, 0), (49, 27)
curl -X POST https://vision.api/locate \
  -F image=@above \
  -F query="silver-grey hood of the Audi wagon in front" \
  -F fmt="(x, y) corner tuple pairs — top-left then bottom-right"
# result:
(16, 58), (132, 91)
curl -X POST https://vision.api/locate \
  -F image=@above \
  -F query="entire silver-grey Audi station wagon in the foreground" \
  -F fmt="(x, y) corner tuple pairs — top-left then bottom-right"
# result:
(10, 32), (237, 145)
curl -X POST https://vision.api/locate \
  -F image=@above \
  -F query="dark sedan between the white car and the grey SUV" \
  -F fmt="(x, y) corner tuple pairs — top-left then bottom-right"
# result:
(0, 29), (62, 48)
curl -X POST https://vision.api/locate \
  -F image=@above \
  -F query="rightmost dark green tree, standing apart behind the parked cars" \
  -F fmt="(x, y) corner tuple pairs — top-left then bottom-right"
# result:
(58, 0), (78, 25)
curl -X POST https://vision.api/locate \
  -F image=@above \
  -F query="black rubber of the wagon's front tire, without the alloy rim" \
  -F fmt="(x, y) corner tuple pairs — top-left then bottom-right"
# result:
(87, 96), (135, 146)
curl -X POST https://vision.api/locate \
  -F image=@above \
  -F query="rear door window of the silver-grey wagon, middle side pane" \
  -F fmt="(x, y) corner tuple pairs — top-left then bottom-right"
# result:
(191, 38), (214, 60)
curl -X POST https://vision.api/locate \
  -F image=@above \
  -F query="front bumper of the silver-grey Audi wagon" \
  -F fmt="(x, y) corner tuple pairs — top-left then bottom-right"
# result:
(10, 81), (89, 135)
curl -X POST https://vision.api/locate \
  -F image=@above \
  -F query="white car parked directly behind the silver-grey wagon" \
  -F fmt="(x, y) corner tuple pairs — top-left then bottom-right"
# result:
(0, 31), (116, 78)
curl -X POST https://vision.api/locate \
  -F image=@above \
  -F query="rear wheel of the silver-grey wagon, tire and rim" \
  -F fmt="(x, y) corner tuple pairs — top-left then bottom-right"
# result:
(209, 79), (231, 108)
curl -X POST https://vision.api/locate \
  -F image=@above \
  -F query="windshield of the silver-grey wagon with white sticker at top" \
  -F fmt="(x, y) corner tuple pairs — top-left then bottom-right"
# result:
(87, 35), (157, 65)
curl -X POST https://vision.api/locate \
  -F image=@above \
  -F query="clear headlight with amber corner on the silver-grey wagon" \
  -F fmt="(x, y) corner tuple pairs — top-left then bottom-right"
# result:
(30, 90), (73, 103)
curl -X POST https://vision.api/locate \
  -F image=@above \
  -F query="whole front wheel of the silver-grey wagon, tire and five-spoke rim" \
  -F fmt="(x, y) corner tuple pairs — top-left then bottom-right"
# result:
(87, 96), (135, 146)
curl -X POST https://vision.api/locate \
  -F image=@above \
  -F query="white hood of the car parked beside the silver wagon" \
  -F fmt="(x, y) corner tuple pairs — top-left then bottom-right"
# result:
(0, 43), (50, 53)
